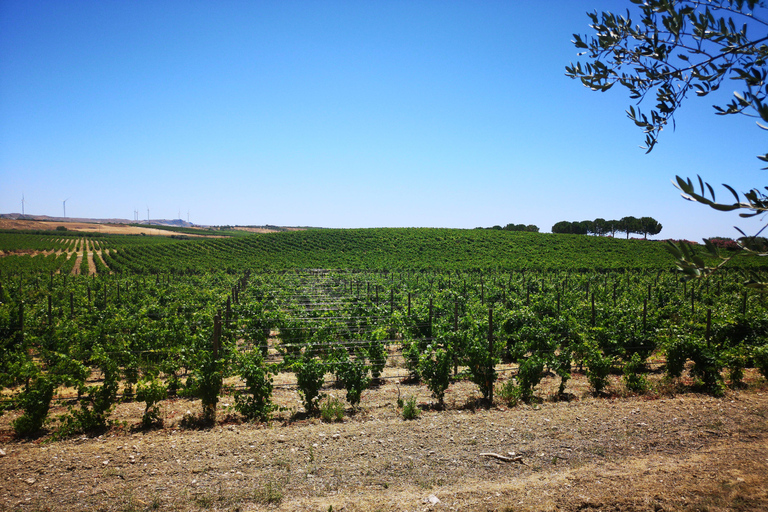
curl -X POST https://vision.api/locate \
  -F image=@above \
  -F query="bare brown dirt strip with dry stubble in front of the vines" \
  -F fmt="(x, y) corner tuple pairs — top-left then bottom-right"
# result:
(0, 369), (768, 511)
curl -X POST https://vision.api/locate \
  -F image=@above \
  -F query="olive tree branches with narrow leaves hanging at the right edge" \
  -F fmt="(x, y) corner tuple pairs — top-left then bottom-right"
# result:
(566, 0), (768, 290)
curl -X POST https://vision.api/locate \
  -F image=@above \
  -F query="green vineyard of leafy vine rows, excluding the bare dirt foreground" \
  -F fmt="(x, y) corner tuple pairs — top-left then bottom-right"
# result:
(0, 229), (768, 512)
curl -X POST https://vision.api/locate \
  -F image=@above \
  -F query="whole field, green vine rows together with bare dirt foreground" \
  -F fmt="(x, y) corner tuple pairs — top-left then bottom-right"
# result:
(0, 225), (768, 511)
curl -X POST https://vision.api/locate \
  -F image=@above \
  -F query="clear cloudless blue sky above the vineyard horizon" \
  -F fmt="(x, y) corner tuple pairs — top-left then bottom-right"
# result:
(0, 0), (768, 240)
